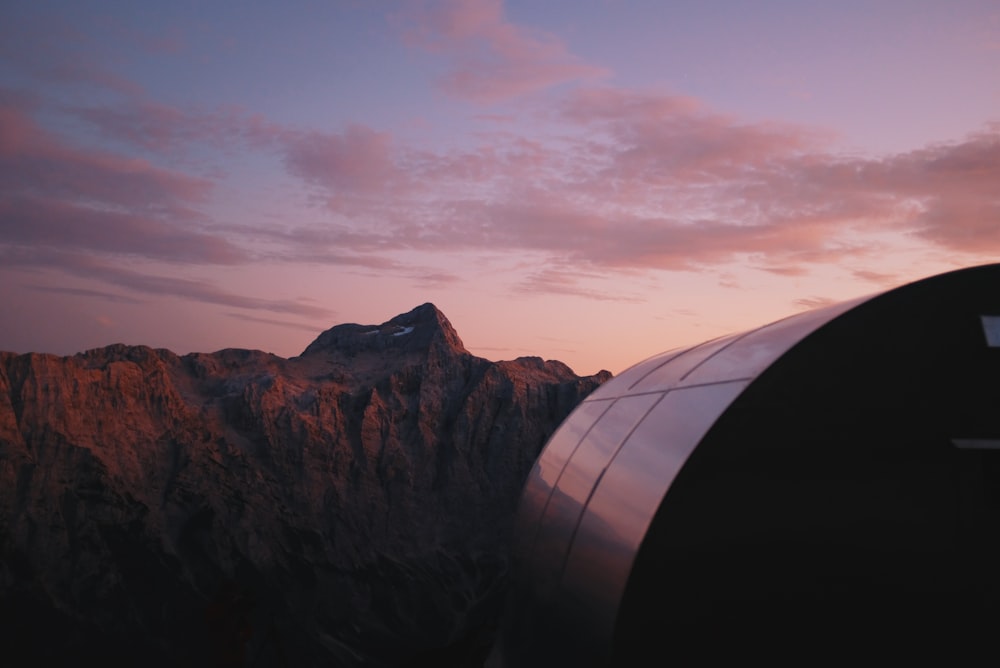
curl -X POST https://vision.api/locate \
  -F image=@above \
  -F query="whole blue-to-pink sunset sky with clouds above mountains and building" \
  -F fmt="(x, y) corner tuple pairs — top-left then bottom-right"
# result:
(0, 0), (1000, 375)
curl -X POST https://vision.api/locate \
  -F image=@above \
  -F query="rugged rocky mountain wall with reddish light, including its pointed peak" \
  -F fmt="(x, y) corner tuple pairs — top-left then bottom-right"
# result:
(0, 304), (610, 667)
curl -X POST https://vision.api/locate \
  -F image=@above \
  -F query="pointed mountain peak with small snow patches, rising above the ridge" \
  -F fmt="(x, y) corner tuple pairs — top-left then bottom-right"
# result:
(302, 302), (468, 356)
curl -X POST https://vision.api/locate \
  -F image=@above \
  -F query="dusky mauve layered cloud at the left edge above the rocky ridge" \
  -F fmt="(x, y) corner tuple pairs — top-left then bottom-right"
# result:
(0, 93), (250, 290)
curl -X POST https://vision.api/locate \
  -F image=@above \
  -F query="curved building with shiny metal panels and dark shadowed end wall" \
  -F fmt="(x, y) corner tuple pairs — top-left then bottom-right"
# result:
(495, 264), (1000, 668)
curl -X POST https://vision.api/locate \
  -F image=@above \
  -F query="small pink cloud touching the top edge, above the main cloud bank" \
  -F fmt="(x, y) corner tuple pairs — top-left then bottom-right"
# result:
(397, 0), (609, 104)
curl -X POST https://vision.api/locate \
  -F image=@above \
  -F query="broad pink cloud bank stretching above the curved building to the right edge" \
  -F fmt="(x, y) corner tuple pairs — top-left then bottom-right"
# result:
(244, 81), (1000, 298)
